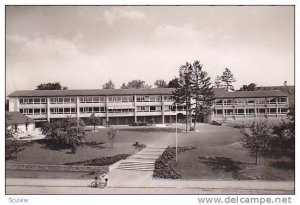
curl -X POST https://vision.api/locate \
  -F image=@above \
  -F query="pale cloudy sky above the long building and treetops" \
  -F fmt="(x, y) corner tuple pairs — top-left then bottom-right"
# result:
(5, 6), (294, 95)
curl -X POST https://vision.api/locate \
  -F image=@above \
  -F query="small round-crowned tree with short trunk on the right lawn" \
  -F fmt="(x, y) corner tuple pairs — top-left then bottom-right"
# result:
(240, 120), (271, 165)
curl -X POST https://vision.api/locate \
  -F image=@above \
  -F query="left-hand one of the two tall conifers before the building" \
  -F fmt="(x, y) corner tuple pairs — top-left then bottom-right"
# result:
(173, 62), (193, 132)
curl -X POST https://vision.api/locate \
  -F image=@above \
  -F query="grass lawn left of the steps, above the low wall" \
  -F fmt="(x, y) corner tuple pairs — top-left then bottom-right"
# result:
(6, 129), (143, 164)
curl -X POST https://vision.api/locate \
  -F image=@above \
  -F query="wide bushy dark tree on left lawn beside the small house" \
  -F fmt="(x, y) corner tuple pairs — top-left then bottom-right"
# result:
(41, 117), (86, 153)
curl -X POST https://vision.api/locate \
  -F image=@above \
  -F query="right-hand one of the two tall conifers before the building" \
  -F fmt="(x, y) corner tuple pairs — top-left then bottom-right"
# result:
(191, 61), (214, 129)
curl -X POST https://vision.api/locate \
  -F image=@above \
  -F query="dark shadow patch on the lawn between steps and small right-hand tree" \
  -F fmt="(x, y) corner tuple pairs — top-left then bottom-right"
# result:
(199, 157), (241, 173)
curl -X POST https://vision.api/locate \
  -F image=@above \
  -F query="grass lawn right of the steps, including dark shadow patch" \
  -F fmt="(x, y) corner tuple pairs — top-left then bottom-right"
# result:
(170, 144), (295, 180)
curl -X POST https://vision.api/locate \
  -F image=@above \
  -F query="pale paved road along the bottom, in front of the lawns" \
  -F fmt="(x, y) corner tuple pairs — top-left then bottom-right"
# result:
(6, 178), (294, 194)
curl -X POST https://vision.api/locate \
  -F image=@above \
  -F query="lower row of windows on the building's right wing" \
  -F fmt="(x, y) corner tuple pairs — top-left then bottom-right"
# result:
(214, 108), (288, 115)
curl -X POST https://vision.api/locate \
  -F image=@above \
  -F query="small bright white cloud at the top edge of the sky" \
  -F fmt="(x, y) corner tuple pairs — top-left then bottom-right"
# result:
(103, 7), (145, 25)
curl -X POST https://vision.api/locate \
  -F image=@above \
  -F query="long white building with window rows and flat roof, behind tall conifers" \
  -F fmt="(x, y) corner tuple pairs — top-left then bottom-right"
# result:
(9, 88), (289, 125)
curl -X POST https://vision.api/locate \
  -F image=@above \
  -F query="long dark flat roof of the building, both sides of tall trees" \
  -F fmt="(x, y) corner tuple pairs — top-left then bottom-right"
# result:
(9, 88), (288, 98)
